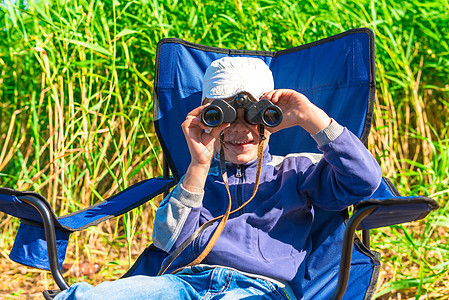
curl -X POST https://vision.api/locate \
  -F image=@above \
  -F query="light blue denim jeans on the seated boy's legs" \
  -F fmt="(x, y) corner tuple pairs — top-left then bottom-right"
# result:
(55, 267), (289, 300)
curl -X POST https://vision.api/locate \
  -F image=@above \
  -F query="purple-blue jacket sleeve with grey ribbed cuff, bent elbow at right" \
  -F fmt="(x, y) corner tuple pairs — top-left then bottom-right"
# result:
(300, 120), (382, 210)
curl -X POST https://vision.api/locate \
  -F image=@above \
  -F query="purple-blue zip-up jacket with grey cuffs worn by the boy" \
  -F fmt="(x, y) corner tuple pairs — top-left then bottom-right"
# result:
(153, 124), (382, 298)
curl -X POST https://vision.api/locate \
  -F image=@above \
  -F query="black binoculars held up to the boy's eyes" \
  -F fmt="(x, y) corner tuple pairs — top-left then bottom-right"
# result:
(201, 94), (282, 127)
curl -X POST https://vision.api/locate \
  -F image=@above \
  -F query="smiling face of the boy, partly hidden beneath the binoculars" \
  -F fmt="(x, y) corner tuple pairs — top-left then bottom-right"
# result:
(211, 108), (270, 165)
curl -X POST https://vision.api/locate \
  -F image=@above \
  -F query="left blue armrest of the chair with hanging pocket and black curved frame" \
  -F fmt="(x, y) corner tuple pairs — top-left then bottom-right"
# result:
(0, 178), (176, 289)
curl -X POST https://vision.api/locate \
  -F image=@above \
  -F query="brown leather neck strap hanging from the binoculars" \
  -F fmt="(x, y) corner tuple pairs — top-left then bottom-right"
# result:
(158, 124), (266, 275)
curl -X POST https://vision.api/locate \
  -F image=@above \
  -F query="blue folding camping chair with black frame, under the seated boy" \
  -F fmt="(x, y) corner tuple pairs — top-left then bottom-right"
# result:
(0, 29), (438, 299)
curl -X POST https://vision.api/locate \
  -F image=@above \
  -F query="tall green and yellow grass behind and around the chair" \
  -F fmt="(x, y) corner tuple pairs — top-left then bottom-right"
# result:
(0, 0), (449, 299)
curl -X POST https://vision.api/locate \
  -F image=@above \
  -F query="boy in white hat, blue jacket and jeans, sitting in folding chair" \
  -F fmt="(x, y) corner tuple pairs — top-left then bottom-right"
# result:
(57, 57), (381, 299)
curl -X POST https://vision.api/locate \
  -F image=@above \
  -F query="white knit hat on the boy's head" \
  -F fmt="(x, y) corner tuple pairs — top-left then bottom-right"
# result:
(202, 57), (274, 101)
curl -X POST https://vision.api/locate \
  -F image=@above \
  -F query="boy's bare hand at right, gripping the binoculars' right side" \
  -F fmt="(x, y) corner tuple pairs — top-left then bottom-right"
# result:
(261, 89), (331, 134)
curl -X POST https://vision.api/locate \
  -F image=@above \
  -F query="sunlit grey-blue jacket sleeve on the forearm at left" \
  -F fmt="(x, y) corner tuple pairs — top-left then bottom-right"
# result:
(153, 180), (204, 252)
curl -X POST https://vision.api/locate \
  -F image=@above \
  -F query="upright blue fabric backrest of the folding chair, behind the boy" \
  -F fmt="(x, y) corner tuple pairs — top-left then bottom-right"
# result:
(154, 29), (376, 178)
